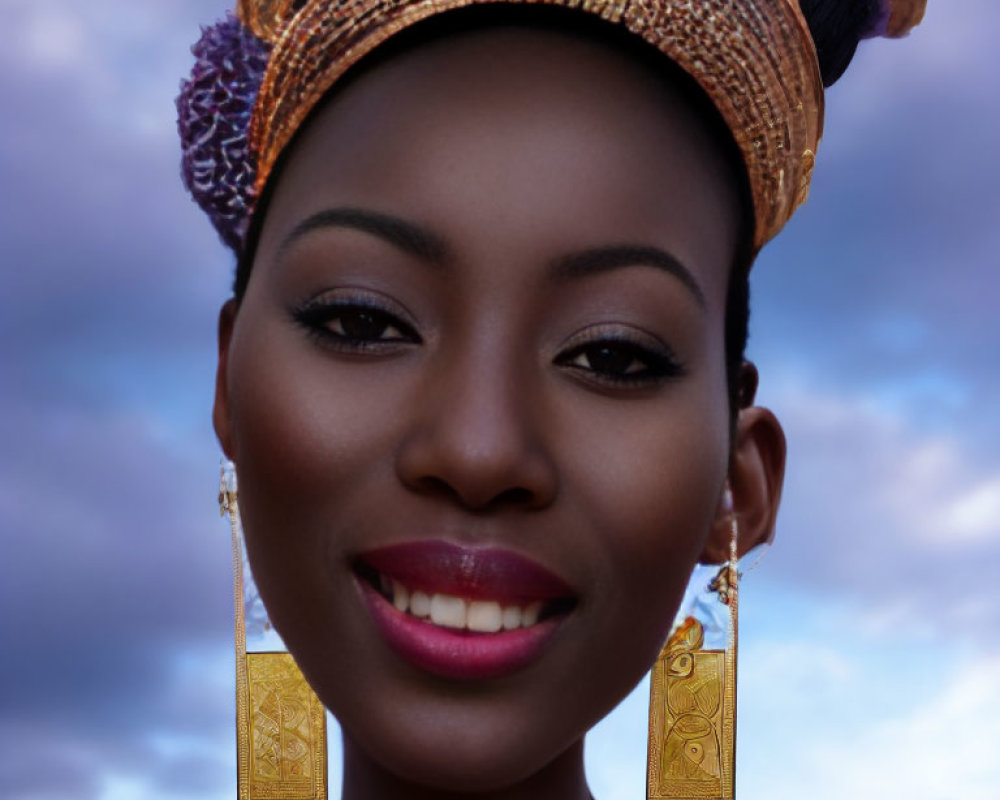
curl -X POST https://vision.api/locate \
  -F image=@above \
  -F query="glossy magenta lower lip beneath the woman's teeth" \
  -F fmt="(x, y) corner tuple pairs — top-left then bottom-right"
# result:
(357, 579), (562, 680)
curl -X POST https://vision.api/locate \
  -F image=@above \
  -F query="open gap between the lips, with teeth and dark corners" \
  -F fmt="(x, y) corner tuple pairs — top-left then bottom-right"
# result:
(355, 562), (576, 634)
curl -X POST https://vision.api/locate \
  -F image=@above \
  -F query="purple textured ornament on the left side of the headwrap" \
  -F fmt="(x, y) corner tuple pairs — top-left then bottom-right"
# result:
(177, 13), (270, 255)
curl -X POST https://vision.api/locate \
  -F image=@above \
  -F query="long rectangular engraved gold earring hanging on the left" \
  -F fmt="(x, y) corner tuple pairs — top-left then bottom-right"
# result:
(219, 461), (327, 800)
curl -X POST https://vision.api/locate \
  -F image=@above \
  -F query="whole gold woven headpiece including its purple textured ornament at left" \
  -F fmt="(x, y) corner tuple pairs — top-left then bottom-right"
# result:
(207, 0), (927, 252)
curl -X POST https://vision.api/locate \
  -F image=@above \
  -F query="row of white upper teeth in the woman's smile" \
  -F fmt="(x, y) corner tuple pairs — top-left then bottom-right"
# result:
(379, 574), (556, 633)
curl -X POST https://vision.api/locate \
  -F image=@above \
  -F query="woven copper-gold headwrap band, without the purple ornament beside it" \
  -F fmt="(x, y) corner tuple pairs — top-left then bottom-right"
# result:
(238, 0), (926, 249)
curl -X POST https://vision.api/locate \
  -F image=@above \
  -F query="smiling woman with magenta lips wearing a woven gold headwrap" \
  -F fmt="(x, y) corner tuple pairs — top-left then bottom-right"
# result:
(181, 0), (922, 800)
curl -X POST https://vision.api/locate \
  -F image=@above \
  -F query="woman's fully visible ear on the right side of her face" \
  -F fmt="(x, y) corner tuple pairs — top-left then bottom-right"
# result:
(700, 365), (786, 564)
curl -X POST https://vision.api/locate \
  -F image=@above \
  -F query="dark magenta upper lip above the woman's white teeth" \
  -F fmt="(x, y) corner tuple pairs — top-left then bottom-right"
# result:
(358, 540), (574, 604)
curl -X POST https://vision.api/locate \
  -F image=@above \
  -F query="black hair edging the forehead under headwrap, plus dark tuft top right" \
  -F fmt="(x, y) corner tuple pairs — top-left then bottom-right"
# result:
(233, 0), (881, 412)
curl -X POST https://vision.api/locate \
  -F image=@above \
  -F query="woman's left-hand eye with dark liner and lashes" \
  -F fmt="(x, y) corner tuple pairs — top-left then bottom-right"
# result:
(292, 297), (423, 353)
